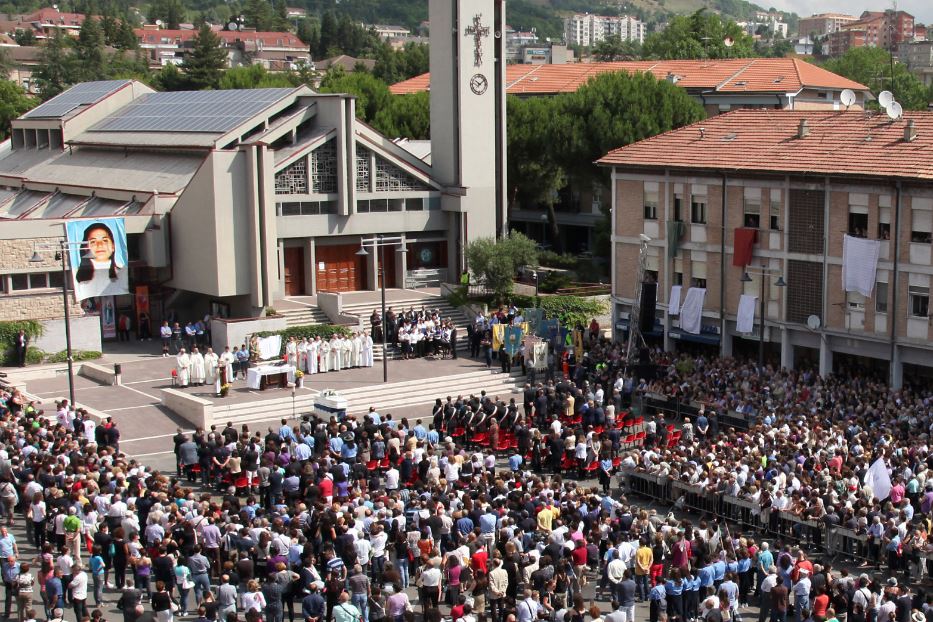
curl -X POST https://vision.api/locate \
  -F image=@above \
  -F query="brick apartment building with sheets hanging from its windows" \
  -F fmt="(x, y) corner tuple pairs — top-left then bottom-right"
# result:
(599, 110), (933, 386)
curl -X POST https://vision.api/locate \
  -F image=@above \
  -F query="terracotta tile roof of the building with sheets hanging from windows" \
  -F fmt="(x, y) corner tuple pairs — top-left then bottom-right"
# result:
(598, 109), (933, 181)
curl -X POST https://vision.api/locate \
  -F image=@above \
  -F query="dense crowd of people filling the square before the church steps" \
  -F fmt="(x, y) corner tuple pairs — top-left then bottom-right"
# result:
(0, 332), (933, 622)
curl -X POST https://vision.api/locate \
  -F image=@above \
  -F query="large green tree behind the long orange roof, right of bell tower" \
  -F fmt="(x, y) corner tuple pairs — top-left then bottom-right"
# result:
(643, 9), (754, 59)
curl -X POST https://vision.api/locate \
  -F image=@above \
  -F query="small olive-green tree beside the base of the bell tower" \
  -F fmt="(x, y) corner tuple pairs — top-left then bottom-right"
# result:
(466, 231), (538, 301)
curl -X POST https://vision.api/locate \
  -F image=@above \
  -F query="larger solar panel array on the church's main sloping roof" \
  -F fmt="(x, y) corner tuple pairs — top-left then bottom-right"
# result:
(91, 89), (292, 134)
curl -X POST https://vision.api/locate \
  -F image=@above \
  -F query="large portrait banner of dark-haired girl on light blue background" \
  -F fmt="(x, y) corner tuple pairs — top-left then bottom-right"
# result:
(65, 218), (129, 300)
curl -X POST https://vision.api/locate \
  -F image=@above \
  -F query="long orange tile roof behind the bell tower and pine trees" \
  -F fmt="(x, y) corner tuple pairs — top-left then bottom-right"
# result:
(389, 58), (868, 95)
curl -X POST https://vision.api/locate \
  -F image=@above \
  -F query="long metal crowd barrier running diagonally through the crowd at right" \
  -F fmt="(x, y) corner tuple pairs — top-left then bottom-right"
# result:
(619, 469), (880, 564)
